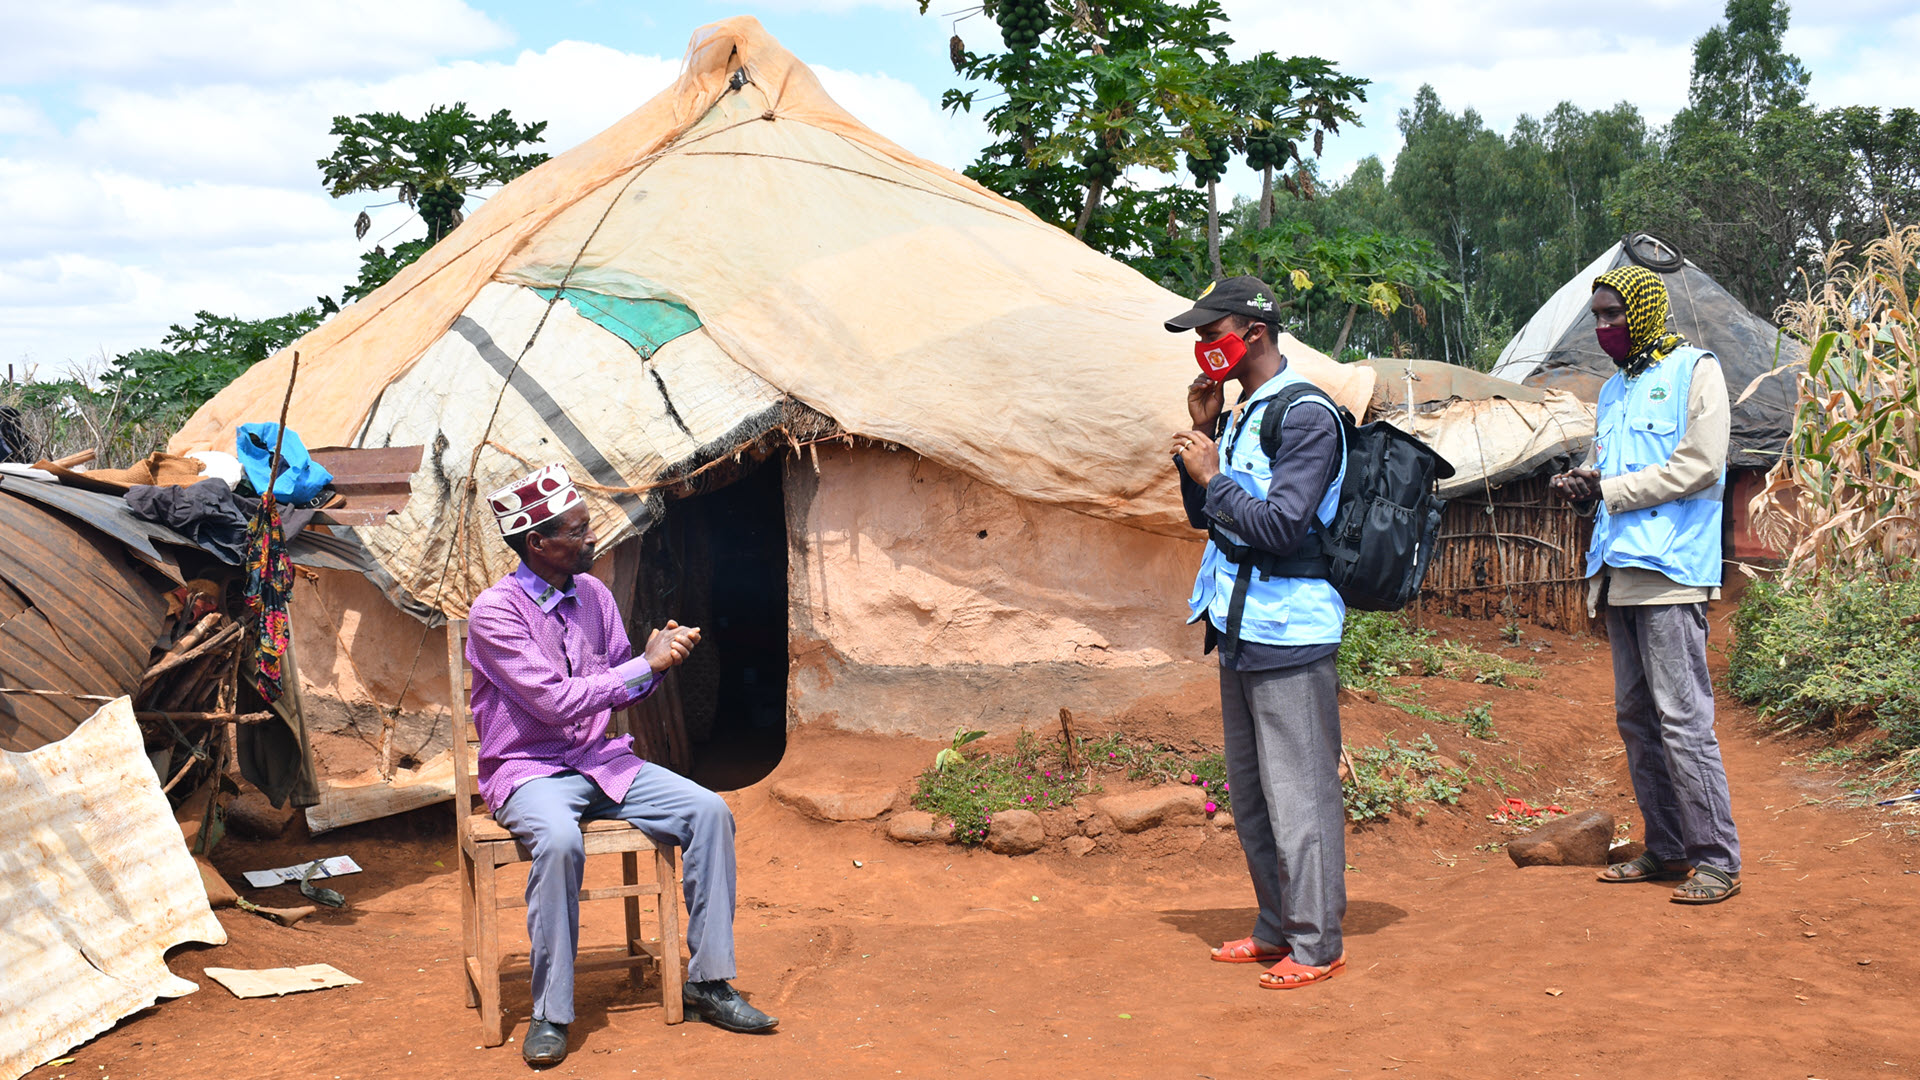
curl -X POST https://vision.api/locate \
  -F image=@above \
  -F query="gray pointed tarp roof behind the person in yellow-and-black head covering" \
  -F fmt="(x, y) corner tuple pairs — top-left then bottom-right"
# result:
(1494, 233), (1807, 469)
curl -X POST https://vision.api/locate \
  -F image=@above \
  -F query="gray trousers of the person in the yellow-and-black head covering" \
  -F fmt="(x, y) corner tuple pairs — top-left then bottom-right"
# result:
(1607, 603), (1740, 874)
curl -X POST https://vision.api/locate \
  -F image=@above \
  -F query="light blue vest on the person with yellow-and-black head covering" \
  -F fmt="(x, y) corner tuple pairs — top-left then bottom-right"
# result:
(1586, 348), (1726, 588)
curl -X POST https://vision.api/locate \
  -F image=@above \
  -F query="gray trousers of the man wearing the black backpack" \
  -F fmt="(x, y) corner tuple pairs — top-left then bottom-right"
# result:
(1219, 657), (1346, 967)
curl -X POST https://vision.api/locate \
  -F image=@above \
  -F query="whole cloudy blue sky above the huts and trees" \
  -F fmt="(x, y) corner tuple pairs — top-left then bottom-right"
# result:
(0, 0), (1920, 379)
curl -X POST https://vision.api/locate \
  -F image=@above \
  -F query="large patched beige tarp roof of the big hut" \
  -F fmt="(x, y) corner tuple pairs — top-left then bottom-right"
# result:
(171, 17), (1373, 611)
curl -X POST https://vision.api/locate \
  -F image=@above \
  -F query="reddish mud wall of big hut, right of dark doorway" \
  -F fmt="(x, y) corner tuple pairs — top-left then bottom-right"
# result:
(785, 446), (1219, 740)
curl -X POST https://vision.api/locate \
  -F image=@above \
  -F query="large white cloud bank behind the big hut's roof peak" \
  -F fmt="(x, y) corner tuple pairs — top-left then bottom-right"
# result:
(0, 32), (983, 373)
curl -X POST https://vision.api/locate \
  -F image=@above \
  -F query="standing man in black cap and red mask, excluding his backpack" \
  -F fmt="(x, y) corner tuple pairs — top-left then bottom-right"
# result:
(1167, 277), (1346, 990)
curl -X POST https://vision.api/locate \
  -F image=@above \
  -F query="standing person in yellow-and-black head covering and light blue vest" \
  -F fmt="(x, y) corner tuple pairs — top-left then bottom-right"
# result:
(1551, 265), (1740, 903)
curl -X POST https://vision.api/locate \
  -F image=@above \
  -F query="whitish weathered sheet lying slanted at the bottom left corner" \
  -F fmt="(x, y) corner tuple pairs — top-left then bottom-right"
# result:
(0, 698), (227, 1080)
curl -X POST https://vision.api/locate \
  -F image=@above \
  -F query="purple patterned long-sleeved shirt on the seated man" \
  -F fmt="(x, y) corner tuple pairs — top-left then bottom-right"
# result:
(467, 563), (659, 811)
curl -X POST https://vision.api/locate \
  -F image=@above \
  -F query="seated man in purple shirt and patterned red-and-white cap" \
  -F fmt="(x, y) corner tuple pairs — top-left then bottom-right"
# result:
(467, 465), (780, 1065)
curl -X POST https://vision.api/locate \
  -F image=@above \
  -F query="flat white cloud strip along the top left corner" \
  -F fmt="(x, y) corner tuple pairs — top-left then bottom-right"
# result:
(0, 0), (513, 85)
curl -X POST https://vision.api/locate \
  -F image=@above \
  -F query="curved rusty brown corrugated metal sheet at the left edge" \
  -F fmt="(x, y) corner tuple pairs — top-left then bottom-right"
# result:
(0, 484), (167, 751)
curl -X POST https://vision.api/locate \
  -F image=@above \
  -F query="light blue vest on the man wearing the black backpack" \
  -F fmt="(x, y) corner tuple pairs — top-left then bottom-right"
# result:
(1187, 367), (1346, 646)
